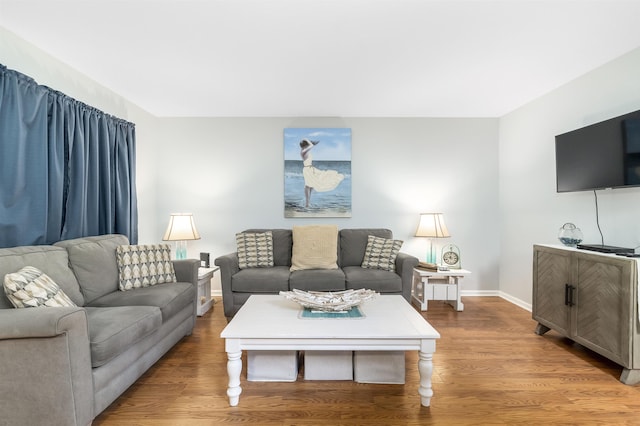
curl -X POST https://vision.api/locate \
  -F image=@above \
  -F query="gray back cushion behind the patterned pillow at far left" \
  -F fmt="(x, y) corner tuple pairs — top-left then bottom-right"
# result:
(0, 246), (84, 309)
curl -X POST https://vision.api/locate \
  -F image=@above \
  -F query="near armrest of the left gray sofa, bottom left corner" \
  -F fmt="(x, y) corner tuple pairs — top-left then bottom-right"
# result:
(0, 307), (93, 426)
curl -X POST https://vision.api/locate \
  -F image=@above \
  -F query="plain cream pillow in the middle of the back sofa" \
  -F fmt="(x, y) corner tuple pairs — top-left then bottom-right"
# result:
(290, 225), (338, 271)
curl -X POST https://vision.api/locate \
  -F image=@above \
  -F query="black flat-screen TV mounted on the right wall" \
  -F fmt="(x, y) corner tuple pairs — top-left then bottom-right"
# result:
(556, 111), (640, 192)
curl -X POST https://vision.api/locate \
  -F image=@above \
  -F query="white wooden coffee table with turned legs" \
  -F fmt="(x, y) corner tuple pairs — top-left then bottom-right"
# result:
(220, 295), (440, 406)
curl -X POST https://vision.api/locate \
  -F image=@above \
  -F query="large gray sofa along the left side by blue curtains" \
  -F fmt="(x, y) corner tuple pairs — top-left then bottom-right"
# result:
(0, 235), (199, 426)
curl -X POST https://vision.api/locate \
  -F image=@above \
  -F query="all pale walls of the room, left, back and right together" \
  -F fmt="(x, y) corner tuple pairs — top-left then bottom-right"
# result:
(5, 28), (640, 310)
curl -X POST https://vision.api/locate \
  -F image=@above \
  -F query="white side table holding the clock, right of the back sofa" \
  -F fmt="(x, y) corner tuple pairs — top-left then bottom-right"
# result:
(411, 268), (471, 311)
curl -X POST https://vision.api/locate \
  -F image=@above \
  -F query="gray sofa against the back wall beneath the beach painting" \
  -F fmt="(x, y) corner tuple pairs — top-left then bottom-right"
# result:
(215, 228), (418, 318)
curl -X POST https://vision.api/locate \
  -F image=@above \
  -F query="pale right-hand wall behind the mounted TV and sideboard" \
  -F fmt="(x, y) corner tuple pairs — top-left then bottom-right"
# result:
(499, 49), (640, 304)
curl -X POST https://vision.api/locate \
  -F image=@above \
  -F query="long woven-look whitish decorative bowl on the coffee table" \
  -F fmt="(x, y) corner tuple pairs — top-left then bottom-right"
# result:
(280, 289), (378, 312)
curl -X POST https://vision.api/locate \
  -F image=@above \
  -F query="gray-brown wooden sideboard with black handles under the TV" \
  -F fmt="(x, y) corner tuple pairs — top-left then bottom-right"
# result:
(532, 245), (640, 385)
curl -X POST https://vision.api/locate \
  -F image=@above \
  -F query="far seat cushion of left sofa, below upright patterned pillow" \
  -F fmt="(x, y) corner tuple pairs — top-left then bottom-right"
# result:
(89, 282), (196, 322)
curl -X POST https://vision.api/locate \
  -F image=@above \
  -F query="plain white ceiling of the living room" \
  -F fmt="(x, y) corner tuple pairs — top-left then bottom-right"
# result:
(0, 0), (640, 117)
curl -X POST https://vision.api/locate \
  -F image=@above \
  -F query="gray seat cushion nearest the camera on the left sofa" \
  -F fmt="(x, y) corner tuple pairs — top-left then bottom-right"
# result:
(85, 306), (162, 368)
